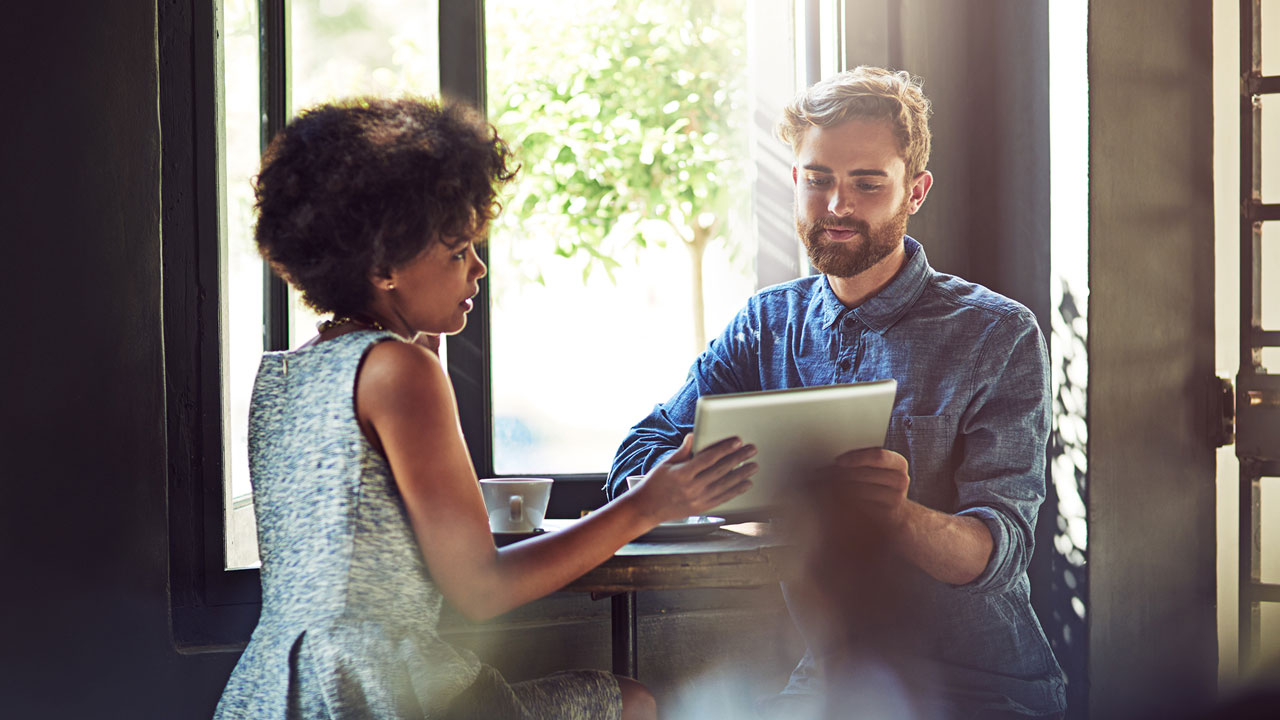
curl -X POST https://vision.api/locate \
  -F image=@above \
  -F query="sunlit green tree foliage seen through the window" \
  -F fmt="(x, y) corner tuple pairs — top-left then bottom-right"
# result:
(488, 0), (748, 279)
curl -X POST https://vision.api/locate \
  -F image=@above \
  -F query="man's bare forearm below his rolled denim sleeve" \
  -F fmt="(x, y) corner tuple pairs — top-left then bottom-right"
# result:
(893, 501), (995, 585)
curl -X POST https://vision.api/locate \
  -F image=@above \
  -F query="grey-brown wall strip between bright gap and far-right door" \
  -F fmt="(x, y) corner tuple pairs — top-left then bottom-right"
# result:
(1088, 0), (1217, 717)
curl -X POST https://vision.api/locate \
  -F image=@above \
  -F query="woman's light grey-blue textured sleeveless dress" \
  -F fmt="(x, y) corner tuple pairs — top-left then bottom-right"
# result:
(215, 331), (621, 720)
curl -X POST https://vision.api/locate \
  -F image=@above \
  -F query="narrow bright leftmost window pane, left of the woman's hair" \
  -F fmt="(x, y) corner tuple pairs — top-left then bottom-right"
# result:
(221, 0), (264, 568)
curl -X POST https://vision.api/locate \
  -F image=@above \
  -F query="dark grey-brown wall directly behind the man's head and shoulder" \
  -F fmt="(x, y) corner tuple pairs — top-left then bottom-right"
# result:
(900, 0), (1050, 337)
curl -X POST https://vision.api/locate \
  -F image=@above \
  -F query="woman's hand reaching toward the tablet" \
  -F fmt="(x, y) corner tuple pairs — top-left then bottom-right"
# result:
(627, 436), (759, 524)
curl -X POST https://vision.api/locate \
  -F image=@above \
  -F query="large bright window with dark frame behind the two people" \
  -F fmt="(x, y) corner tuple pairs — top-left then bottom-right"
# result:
(160, 0), (817, 647)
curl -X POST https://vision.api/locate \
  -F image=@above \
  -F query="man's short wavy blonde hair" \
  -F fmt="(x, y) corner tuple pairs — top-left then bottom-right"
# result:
(776, 65), (932, 182)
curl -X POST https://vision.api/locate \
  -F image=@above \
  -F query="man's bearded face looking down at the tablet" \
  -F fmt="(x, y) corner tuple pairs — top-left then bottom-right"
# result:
(791, 120), (932, 278)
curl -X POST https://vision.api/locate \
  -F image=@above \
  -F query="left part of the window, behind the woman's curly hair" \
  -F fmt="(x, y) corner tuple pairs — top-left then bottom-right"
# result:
(220, 0), (439, 569)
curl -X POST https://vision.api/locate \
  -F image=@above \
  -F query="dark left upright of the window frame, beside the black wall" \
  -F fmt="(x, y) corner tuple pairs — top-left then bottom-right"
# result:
(165, 1), (261, 652)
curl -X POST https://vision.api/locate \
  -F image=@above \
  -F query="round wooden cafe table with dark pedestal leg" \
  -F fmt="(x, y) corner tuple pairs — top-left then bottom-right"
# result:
(543, 519), (786, 678)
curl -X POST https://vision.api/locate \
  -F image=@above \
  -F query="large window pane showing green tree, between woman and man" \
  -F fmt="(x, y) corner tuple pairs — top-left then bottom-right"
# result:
(485, 0), (755, 474)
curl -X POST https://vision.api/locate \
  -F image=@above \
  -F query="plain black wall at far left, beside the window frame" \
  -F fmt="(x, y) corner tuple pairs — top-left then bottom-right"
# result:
(0, 0), (234, 719)
